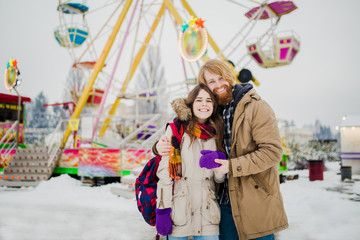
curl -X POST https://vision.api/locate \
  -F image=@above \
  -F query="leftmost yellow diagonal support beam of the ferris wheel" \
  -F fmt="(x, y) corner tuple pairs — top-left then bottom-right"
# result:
(60, 0), (133, 148)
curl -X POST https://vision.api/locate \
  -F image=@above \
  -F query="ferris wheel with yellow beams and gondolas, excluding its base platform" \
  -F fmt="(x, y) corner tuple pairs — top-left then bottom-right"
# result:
(54, 0), (300, 147)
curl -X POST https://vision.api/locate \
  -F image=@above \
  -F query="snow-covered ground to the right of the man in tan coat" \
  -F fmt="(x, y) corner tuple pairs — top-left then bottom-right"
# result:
(278, 162), (360, 240)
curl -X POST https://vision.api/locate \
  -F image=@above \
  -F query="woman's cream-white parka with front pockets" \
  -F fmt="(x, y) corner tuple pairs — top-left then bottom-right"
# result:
(157, 127), (224, 237)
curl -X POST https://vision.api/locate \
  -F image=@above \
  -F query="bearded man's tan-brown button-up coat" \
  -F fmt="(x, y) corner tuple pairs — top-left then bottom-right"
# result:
(229, 89), (288, 240)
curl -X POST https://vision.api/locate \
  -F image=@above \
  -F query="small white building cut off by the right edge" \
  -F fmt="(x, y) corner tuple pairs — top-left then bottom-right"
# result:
(339, 114), (360, 174)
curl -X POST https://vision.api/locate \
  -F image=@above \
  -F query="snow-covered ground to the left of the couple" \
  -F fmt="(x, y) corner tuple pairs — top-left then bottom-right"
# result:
(0, 175), (155, 240)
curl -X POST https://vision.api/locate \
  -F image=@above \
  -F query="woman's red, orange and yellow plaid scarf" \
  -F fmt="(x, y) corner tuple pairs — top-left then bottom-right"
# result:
(169, 118), (216, 180)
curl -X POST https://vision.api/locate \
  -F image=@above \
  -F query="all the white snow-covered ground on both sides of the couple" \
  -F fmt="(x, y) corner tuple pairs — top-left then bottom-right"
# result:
(0, 162), (360, 240)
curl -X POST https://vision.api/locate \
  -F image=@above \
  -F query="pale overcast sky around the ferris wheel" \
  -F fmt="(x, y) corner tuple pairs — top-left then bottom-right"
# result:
(0, 0), (360, 131)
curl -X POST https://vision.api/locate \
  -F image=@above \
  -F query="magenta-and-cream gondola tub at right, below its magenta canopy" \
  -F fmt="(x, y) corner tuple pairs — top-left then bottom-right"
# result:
(247, 31), (300, 68)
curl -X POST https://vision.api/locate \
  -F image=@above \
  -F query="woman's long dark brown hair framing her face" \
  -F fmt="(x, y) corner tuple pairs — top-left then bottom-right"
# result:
(185, 84), (224, 151)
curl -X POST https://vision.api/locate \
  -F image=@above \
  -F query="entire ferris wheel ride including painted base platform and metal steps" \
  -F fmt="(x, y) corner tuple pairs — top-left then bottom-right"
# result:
(0, 0), (300, 185)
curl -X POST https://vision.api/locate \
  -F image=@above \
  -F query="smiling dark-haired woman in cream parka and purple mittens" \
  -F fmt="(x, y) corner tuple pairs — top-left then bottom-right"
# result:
(156, 84), (225, 240)
